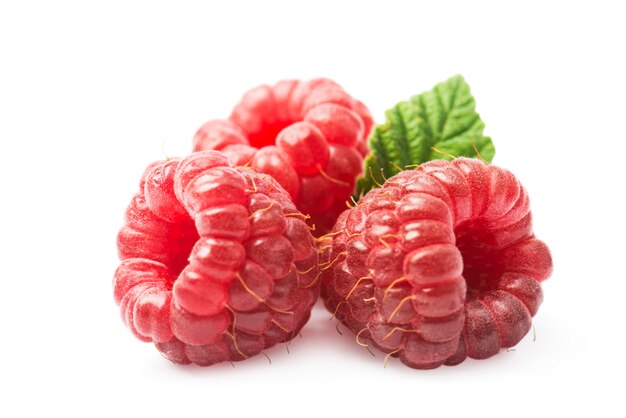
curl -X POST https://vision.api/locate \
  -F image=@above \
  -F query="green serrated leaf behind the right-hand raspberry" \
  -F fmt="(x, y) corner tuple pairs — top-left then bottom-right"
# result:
(355, 75), (496, 199)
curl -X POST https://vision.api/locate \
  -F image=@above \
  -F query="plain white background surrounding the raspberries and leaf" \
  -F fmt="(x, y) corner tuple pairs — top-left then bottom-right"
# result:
(0, 0), (626, 417)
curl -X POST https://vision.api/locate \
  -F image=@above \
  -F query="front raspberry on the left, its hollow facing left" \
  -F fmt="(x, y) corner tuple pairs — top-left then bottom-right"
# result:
(113, 151), (319, 366)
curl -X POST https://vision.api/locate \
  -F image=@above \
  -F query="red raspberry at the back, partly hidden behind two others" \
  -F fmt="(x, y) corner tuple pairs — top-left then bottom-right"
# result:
(193, 78), (373, 235)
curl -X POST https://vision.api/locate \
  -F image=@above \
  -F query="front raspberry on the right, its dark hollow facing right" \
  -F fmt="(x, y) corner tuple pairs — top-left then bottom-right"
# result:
(320, 158), (552, 369)
